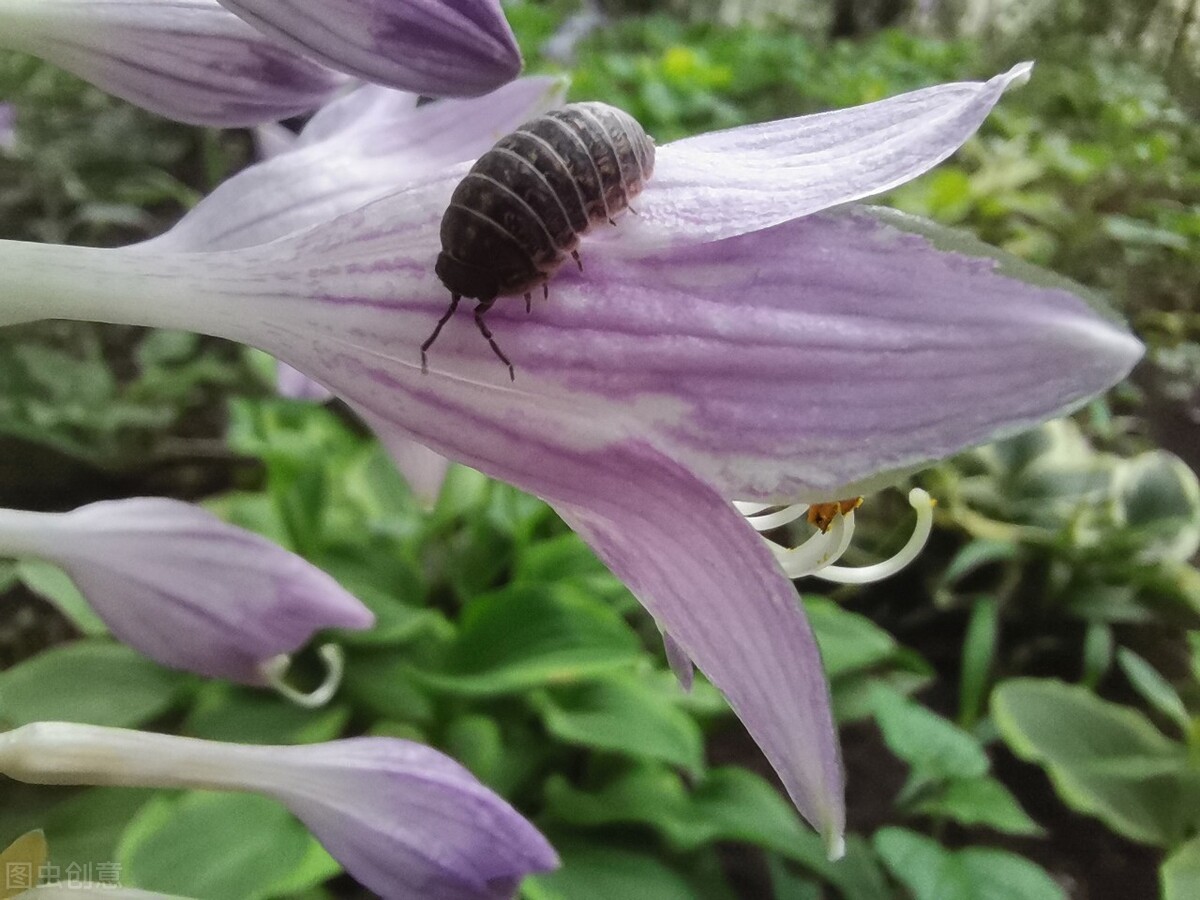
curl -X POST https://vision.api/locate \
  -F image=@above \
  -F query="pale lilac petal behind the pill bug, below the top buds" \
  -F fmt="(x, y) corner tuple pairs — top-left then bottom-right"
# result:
(141, 77), (565, 252)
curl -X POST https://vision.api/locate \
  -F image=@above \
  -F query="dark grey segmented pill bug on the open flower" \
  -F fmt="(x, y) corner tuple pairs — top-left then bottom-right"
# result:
(421, 103), (654, 378)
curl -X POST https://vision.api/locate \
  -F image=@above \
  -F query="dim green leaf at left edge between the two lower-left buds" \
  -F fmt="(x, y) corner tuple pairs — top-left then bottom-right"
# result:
(0, 638), (191, 728)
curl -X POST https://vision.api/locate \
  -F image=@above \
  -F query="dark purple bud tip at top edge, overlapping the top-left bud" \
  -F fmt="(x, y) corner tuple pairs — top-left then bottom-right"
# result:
(220, 0), (521, 97)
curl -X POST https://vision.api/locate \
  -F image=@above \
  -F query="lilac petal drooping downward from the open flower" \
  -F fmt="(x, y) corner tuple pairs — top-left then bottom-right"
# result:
(552, 446), (845, 857)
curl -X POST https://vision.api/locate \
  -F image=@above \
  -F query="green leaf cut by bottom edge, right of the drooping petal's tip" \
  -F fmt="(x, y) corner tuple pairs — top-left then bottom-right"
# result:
(875, 828), (1066, 900)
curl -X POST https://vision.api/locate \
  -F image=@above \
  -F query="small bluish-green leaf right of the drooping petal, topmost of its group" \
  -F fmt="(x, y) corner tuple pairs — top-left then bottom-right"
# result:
(871, 684), (988, 779)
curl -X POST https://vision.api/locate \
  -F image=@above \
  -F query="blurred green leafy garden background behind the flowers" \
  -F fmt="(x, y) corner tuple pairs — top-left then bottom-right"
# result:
(0, 0), (1200, 900)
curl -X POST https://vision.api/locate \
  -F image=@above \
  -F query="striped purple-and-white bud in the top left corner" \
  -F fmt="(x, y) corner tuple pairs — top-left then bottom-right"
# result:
(0, 0), (346, 127)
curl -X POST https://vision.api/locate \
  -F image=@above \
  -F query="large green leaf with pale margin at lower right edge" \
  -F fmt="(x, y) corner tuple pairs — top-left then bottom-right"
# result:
(991, 678), (1200, 846)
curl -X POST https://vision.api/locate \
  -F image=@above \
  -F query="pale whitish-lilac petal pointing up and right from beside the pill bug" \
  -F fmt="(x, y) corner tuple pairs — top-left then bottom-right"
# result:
(596, 62), (1032, 254)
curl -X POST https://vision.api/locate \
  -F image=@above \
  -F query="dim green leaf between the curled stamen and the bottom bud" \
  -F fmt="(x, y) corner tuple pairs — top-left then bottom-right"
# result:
(181, 684), (350, 744)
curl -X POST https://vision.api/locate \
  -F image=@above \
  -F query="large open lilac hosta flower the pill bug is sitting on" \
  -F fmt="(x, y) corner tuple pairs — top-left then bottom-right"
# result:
(0, 67), (1141, 852)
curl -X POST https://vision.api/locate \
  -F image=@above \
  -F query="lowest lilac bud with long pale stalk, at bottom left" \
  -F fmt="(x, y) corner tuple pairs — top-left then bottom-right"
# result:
(0, 722), (558, 900)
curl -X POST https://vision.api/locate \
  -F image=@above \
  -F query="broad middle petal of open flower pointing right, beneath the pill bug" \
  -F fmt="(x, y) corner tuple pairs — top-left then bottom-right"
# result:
(133, 175), (1141, 502)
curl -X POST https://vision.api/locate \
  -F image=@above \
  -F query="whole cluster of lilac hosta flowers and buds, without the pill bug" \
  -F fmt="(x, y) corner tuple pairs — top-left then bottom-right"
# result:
(0, 0), (1141, 898)
